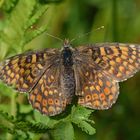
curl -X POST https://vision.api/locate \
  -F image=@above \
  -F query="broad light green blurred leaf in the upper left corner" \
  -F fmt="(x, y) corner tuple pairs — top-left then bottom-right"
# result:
(1, 0), (35, 48)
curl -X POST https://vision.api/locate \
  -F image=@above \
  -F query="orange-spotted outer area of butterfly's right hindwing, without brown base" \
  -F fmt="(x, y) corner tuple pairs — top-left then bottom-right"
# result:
(78, 72), (119, 110)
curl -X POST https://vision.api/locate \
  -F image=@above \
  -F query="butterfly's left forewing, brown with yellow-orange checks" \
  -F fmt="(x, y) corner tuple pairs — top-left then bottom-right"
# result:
(0, 49), (58, 92)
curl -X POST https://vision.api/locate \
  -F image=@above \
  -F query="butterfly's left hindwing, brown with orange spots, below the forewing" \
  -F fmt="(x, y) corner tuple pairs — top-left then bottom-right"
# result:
(29, 62), (72, 116)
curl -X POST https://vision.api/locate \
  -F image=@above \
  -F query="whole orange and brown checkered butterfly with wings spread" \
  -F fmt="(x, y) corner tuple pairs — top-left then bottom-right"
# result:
(0, 40), (140, 116)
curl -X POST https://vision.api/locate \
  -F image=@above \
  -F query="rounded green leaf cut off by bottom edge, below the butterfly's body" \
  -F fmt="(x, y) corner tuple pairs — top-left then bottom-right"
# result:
(51, 122), (74, 140)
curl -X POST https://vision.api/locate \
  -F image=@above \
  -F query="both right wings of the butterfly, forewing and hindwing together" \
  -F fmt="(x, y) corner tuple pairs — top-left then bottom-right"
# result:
(76, 43), (140, 109)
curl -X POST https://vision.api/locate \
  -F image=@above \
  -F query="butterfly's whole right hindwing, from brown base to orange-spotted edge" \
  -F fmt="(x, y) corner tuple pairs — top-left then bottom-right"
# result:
(73, 58), (119, 110)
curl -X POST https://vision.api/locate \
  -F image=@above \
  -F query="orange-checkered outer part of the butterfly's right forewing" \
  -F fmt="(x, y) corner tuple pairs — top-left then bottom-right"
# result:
(91, 43), (140, 81)
